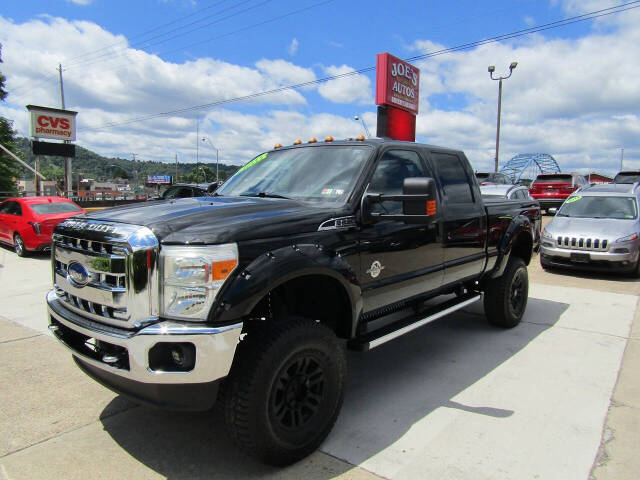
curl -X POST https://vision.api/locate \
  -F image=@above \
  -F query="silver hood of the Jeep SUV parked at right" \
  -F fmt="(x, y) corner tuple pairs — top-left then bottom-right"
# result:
(546, 217), (638, 242)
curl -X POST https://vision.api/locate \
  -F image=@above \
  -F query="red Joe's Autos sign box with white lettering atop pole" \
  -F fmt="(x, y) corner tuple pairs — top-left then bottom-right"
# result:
(376, 53), (420, 115)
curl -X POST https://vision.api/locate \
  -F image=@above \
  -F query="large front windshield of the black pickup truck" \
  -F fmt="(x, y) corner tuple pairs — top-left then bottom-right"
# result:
(216, 145), (371, 203)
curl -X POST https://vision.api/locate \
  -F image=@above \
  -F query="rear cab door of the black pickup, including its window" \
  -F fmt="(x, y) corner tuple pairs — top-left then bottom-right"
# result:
(429, 151), (486, 284)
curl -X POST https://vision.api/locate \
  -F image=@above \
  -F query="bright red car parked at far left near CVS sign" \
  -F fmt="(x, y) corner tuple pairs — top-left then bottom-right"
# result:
(0, 197), (87, 257)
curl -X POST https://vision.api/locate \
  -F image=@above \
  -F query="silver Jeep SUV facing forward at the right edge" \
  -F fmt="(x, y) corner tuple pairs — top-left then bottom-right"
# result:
(540, 182), (640, 275)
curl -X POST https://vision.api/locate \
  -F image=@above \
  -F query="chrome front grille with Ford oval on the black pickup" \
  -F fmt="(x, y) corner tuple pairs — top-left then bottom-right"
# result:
(52, 218), (158, 328)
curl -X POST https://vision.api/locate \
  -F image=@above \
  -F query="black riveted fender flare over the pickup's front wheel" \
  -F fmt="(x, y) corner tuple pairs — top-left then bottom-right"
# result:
(209, 244), (362, 336)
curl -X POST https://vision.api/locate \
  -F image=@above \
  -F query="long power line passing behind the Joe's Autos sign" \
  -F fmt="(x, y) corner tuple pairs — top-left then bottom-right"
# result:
(78, 0), (640, 131)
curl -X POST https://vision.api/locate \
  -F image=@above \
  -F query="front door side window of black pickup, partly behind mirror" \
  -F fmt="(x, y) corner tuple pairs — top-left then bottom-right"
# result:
(367, 150), (425, 215)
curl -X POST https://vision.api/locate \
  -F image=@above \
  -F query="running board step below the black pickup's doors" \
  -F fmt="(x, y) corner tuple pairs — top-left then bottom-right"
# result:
(348, 293), (482, 352)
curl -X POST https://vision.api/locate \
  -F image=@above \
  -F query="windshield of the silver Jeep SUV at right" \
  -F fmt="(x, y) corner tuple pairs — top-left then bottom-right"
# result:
(556, 195), (638, 220)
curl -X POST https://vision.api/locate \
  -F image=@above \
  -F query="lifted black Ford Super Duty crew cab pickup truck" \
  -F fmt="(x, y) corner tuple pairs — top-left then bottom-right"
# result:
(47, 137), (540, 465)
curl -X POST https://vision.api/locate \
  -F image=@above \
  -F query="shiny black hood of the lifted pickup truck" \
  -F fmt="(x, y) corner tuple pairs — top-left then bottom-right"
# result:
(87, 197), (333, 244)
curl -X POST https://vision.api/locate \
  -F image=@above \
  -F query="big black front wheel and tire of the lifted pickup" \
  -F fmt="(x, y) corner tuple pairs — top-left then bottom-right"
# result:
(218, 317), (347, 466)
